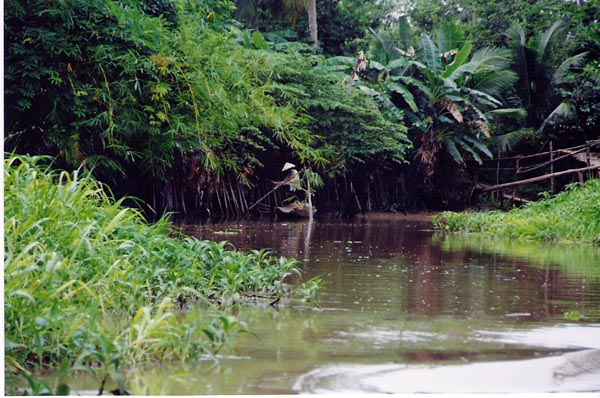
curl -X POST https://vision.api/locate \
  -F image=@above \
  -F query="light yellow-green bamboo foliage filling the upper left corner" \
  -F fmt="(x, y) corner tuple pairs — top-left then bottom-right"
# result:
(6, 1), (314, 179)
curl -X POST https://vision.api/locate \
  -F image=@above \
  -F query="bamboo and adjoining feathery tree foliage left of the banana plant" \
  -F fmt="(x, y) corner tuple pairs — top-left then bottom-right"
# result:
(5, 0), (408, 215)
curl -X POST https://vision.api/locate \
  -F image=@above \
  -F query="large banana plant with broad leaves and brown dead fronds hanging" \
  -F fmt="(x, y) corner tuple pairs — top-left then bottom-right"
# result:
(328, 19), (525, 176)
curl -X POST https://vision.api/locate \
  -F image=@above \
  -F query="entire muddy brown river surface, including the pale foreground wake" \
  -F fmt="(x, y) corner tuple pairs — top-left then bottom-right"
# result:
(37, 214), (600, 395)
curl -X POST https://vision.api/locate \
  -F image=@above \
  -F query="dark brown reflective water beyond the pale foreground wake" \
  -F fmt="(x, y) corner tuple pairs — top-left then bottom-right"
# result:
(185, 216), (600, 322)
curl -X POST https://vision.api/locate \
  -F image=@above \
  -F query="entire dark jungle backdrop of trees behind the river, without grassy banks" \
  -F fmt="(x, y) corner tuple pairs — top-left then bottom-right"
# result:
(5, 0), (600, 217)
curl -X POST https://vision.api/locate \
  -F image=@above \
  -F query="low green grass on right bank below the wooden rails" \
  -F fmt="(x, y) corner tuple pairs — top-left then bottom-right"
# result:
(433, 179), (600, 244)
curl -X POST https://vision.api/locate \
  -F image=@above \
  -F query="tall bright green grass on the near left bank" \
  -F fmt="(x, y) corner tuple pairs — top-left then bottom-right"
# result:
(4, 156), (320, 393)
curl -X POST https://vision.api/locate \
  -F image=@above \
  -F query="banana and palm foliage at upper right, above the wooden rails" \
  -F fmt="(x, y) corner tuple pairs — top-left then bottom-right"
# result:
(354, 0), (599, 208)
